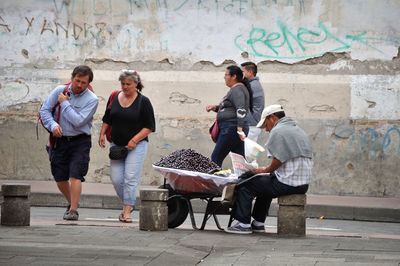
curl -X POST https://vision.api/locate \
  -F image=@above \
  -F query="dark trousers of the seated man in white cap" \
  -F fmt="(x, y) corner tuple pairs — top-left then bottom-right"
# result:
(232, 174), (308, 224)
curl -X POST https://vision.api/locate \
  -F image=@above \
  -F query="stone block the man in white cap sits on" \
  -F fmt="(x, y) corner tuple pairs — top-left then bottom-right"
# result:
(278, 194), (307, 236)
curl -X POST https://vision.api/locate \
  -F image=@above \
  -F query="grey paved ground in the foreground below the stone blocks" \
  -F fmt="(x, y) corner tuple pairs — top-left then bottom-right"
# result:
(0, 207), (400, 266)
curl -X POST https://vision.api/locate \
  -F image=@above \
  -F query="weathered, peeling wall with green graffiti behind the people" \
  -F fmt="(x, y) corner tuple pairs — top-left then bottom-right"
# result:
(0, 0), (400, 197)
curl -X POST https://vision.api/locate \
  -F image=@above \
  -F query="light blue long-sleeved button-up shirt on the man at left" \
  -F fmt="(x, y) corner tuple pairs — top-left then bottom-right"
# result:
(40, 85), (99, 136)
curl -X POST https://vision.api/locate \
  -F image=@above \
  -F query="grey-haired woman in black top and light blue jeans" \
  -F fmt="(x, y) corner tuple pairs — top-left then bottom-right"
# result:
(99, 70), (155, 223)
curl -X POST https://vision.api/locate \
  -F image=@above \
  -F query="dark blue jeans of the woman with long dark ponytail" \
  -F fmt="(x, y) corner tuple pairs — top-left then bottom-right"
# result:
(211, 121), (249, 167)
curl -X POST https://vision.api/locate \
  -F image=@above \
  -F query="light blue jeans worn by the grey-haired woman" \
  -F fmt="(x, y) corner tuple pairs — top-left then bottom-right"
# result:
(110, 140), (149, 206)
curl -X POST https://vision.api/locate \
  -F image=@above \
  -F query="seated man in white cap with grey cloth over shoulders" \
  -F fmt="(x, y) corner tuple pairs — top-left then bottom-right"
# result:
(225, 104), (313, 234)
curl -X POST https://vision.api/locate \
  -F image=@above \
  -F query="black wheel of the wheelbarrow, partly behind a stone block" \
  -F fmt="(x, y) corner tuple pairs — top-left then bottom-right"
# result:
(167, 196), (189, 228)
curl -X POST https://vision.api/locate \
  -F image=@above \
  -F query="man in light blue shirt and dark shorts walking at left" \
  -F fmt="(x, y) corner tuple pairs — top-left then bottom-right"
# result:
(40, 65), (98, 220)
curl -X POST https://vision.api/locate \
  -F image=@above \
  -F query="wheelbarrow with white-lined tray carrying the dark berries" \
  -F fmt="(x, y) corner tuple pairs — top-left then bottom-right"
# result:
(153, 165), (237, 230)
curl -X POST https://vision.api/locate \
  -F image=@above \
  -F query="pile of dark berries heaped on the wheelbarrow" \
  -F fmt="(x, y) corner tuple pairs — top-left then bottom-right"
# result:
(154, 149), (219, 173)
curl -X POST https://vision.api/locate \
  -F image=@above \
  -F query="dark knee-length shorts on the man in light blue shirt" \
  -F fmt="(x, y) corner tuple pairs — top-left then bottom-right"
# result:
(51, 135), (92, 182)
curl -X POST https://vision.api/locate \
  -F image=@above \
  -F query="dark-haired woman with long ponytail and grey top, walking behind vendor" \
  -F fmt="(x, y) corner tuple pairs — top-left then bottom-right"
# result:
(206, 65), (253, 166)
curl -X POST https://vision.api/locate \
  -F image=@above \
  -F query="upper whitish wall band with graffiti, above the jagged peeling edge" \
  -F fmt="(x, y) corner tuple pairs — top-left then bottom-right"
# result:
(0, 0), (400, 66)
